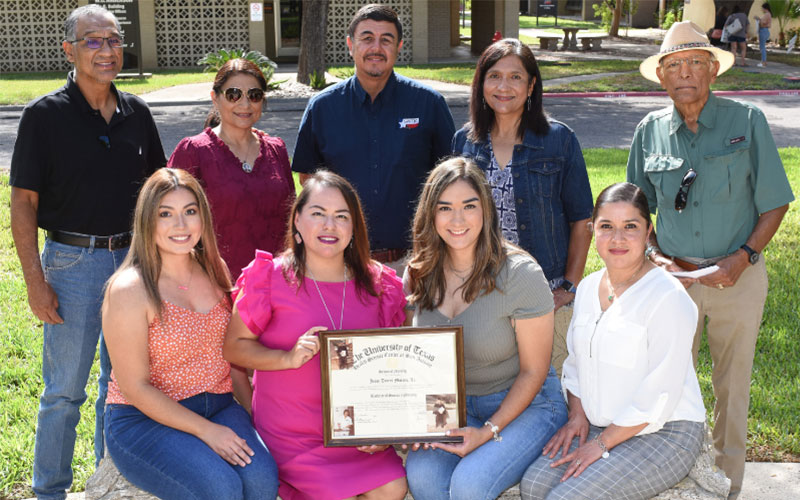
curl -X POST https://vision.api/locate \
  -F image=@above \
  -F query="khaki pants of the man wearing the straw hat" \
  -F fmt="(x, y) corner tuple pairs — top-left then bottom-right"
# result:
(688, 255), (767, 498)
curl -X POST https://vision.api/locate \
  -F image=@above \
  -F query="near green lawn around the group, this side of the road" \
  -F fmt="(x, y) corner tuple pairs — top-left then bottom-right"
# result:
(0, 148), (800, 500)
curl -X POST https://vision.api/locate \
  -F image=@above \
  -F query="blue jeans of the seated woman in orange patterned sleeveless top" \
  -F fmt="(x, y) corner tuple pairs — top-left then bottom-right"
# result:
(105, 392), (278, 500)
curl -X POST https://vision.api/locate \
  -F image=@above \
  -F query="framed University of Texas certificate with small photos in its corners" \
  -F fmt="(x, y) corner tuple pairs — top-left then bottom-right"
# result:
(319, 326), (467, 446)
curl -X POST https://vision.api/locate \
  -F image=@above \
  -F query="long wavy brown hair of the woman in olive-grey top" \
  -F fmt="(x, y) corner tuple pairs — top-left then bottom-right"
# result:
(408, 157), (516, 310)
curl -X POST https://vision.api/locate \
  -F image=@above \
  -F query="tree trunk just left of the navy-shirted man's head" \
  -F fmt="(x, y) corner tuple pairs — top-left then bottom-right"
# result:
(297, 0), (330, 85)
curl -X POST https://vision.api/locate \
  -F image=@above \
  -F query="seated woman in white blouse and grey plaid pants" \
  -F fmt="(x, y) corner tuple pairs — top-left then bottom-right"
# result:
(520, 183), (705, 500)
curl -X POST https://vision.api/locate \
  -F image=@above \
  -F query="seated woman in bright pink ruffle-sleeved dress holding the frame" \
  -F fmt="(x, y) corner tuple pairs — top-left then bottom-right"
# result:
(223, 171), (407, 500)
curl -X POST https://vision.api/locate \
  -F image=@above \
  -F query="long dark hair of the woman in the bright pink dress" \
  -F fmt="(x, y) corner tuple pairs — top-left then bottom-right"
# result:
(281, 170), (379, 297)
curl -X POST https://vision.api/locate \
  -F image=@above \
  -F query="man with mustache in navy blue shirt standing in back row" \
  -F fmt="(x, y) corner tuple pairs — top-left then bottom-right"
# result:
(292, 4), (455, 268)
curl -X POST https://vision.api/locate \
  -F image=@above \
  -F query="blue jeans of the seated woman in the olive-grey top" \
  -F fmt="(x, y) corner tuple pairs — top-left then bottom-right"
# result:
(406, 367), (567, 500)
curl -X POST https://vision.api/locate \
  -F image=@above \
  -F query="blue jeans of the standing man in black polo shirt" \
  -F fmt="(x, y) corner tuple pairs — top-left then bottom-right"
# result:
(33, 240), (128, 500)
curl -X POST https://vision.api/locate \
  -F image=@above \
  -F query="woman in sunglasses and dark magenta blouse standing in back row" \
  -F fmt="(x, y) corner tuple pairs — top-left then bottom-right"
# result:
(167, 59), (295, 278)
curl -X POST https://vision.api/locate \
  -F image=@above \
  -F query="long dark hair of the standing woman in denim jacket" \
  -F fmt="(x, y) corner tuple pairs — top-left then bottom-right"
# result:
(467, 38), (550, 142)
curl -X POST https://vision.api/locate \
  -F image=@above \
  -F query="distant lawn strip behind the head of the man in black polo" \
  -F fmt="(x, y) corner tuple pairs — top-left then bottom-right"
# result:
(0, 69), (214, 105)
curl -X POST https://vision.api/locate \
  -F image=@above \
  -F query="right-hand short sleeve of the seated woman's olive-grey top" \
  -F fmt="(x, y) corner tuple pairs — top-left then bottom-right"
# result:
(501, 254), (554, 319)
